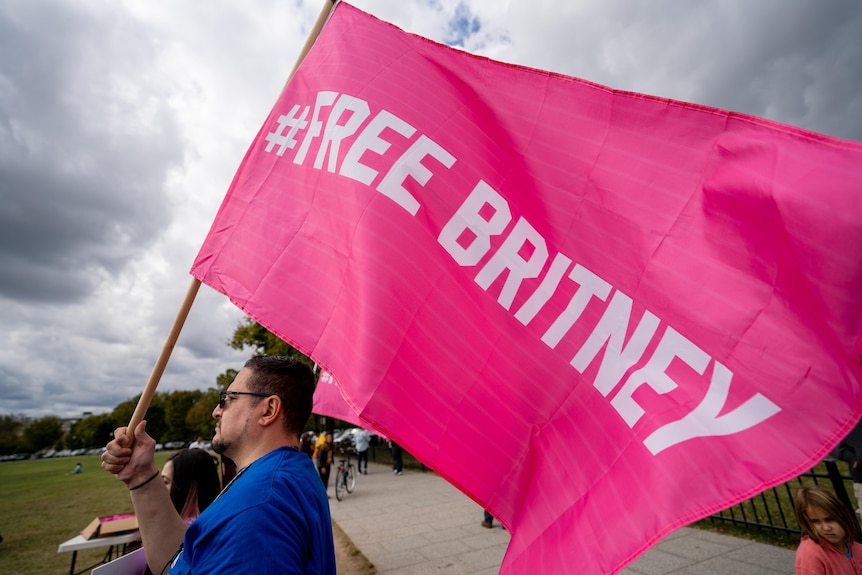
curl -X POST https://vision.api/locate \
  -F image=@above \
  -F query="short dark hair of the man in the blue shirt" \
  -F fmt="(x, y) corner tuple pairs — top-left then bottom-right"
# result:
(245, 355), (315, 437)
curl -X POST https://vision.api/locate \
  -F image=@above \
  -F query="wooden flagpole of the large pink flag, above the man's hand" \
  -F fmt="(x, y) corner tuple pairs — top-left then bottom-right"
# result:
(127, 0), (337, 436)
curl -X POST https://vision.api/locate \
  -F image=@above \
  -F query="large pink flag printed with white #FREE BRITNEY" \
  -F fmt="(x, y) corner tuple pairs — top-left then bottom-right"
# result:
(192, 3), (862, 575)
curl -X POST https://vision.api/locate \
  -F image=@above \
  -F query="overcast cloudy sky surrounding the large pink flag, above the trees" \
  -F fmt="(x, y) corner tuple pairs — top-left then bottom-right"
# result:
(0, 0), (862, 424)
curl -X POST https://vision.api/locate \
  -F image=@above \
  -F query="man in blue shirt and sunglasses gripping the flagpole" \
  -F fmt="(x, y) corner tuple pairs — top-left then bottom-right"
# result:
(102, 356), (335, 575)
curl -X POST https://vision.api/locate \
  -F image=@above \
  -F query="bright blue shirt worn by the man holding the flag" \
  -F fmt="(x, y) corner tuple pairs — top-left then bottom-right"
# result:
(170, 447), (335, 575)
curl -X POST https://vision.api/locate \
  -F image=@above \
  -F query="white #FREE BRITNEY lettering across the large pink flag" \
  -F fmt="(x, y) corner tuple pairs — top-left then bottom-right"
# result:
(265, 91), (780, 455)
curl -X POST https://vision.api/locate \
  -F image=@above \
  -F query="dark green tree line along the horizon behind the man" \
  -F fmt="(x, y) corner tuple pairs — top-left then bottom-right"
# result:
(0, 318), (328, 455)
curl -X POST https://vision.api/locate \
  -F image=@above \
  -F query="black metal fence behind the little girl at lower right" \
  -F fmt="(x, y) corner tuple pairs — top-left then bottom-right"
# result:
(708, 460), (859, 536)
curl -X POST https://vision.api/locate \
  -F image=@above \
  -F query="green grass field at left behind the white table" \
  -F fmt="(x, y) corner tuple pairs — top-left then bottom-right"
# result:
(0, 452), (170, 575)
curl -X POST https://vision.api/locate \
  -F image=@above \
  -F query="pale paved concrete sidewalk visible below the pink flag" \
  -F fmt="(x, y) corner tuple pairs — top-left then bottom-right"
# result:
(329, 463), (794, 575)
